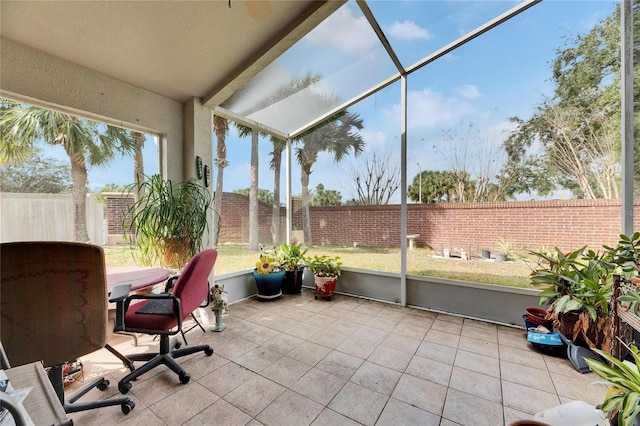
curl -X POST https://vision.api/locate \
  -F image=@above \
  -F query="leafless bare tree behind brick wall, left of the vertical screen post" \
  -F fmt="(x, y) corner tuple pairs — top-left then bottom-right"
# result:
(348, 148), (400, 205)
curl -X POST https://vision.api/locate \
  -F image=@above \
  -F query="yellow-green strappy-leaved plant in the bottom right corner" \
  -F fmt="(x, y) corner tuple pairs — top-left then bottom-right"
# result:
(585, 344), (640, 426)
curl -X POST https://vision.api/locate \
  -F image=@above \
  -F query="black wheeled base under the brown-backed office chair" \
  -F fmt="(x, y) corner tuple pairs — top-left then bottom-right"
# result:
(49, 365), (136, 414)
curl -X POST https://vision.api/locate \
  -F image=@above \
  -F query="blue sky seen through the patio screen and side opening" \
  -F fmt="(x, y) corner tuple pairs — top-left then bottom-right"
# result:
(38, 0), (615, 202)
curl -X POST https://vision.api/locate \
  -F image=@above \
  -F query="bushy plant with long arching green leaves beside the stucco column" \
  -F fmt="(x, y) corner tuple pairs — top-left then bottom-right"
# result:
(123, 175), (211, 269)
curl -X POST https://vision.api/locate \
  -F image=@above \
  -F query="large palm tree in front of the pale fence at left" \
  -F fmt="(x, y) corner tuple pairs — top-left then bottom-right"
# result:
(0, 103), (135, 242)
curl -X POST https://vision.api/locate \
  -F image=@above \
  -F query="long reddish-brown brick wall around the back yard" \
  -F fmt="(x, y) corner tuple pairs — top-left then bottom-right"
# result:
(107, 193), (640, 254)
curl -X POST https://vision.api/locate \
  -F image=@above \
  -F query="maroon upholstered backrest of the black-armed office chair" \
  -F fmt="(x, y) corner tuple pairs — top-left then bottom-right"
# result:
(172, 249), (218, 319)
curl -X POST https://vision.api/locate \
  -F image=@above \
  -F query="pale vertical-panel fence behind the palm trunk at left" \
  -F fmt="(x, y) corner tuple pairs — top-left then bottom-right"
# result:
(0, 192), (106, 245)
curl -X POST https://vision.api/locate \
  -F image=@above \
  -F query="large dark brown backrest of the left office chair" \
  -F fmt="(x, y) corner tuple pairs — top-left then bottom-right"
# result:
(0, 241), (107, 366)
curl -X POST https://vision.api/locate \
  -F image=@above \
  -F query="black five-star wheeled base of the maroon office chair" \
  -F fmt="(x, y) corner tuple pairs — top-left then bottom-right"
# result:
(118, 335), (213, 394)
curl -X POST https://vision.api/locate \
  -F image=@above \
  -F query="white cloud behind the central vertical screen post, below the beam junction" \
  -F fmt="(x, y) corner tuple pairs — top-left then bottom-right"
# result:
(386, 89), (476, 129)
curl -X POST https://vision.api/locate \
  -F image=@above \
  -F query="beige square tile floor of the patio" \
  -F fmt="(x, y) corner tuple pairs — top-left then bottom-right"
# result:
(68, 289), (606, 426)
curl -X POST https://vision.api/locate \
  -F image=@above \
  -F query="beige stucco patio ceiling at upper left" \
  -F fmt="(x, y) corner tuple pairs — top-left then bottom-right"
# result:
(0, 0), (344, 106)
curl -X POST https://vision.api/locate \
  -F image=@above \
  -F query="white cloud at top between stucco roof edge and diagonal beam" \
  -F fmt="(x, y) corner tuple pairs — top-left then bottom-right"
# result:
(305, 7), (380, 54)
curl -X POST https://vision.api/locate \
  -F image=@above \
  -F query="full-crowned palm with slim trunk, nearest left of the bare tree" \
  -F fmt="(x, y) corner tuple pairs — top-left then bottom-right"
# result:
(296, 111), (364, 247)
